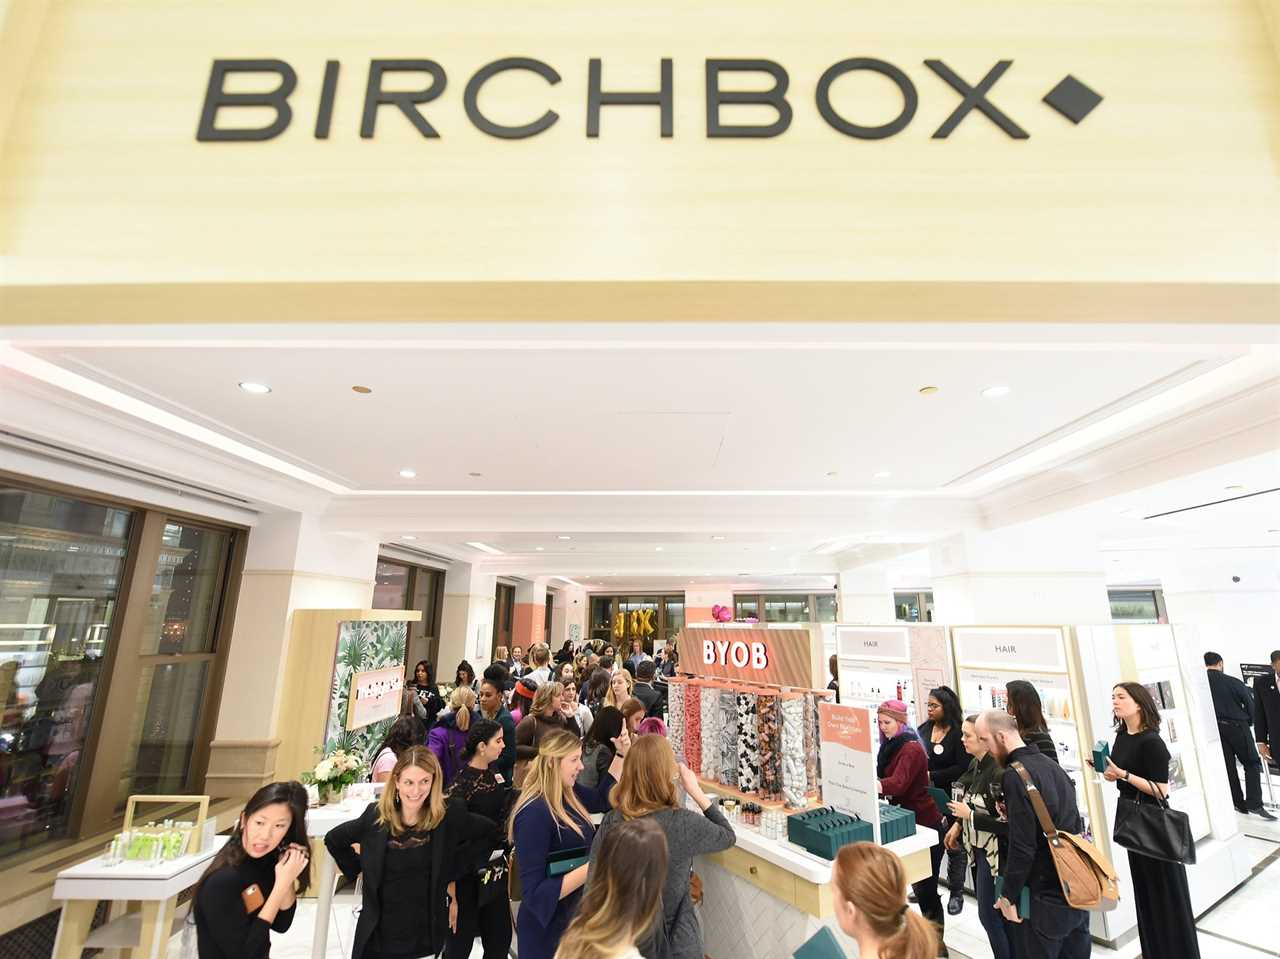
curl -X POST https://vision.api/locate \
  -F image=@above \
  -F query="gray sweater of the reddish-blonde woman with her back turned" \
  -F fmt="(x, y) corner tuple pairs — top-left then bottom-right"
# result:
(586, 803), (737, 959)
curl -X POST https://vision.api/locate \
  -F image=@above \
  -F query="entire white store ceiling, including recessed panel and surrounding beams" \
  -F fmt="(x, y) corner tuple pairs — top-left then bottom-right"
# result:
(0, 323), (1280, 590)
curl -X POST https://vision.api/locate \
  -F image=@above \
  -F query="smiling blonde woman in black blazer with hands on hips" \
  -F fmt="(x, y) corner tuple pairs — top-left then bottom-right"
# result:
(324, 746), (493, 959)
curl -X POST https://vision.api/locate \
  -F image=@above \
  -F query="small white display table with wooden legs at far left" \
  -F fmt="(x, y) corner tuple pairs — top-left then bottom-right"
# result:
(52, 836), (227, 959)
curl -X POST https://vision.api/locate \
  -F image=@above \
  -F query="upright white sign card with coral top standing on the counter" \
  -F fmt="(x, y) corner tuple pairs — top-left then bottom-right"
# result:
(818, 703), (881, 842)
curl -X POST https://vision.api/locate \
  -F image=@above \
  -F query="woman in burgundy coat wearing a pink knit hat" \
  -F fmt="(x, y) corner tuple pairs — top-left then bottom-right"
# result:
(876, 699), (947, 955)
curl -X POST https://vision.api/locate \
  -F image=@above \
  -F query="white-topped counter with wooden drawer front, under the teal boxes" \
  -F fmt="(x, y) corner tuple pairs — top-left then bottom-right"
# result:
(694, 823), (938, 959)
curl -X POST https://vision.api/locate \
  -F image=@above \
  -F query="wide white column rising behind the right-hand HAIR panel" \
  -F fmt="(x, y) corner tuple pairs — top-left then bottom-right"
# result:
(929, 524), (1111, 626)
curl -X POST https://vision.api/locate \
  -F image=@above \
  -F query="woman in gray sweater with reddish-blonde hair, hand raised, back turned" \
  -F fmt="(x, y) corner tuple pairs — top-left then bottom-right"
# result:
(586, 736), (737, 959)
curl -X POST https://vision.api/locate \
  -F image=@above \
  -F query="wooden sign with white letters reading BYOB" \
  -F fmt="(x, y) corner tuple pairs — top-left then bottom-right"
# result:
(677, 625), (822, 689)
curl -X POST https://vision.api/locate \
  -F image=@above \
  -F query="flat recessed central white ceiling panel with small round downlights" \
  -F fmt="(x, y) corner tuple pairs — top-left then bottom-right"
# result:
(36, 335), (1210, 490)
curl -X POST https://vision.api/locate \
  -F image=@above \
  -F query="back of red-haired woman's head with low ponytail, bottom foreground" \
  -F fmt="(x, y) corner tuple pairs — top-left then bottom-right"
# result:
(831, 842), (946, 959)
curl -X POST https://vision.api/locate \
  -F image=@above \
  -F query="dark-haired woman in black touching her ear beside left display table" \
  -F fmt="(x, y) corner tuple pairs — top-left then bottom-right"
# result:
(191, 782), (311, 959)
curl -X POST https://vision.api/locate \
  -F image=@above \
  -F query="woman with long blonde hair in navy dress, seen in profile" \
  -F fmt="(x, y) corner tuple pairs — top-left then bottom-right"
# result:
(508, 729), (631, 959)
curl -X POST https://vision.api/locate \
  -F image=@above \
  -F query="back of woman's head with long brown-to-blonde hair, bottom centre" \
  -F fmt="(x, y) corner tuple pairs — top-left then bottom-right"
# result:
(556, 819), (668, 959)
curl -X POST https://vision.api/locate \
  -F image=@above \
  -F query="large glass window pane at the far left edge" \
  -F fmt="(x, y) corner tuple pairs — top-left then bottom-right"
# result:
(0, 487), (133, 857)
